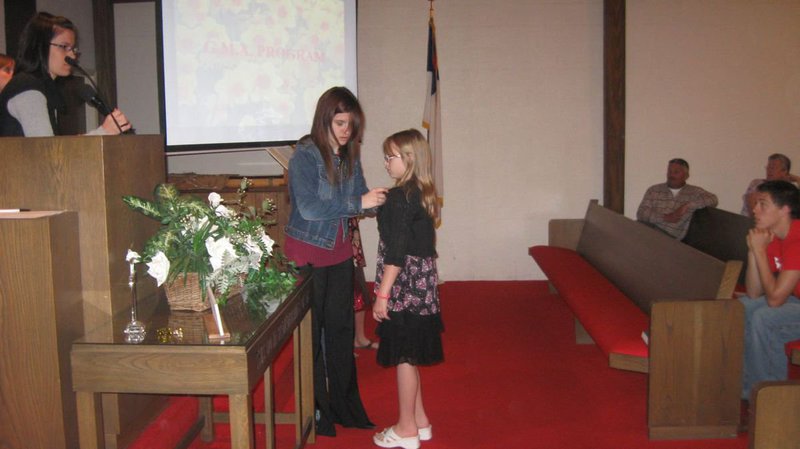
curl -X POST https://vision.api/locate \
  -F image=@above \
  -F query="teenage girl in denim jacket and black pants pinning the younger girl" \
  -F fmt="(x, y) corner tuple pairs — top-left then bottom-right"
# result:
(285, 87), (387, 436)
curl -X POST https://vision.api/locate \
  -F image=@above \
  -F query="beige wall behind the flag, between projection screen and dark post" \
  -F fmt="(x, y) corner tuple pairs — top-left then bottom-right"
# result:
(358, 0), (603, 280)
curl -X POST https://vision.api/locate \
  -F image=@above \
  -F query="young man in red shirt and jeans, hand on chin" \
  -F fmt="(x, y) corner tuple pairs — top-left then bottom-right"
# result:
(739, 181), (800, 399)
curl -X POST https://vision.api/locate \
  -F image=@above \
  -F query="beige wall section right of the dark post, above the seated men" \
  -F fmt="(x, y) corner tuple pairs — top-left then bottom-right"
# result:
(625, 0), (800, 215)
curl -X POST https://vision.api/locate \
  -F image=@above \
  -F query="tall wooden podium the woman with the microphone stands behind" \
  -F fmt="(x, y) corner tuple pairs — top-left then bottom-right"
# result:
(0, 135), (166, 448)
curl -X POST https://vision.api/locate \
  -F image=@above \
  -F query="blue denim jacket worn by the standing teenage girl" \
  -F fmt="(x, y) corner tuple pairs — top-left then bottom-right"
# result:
(286, 139), (368, 249)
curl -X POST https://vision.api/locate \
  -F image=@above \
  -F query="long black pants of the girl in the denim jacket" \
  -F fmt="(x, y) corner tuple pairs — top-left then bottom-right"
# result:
(311, 259), (375, 436)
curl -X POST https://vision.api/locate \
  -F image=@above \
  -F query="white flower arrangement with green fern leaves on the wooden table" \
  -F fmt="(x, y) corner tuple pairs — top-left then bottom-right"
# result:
(122, 178), (296, 308)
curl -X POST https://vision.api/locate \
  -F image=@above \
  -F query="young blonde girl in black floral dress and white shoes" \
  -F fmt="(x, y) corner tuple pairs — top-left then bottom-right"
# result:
(372, 129), (444, 449)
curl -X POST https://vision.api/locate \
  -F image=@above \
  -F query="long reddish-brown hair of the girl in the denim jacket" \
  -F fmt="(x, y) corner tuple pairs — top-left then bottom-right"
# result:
(308, 87), (364, 184)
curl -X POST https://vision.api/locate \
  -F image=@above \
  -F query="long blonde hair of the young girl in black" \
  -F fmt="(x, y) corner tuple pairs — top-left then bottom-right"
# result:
(383, 128), (439, 220)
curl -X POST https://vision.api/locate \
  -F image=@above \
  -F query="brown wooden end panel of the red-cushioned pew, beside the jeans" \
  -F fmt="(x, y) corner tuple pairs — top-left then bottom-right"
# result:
(648, 299), (744, 439)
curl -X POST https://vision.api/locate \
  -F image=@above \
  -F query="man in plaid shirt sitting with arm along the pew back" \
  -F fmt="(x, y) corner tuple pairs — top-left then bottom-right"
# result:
(636, 159), (717, 240)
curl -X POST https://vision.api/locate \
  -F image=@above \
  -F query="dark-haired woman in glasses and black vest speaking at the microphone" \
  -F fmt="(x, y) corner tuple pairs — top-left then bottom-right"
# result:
(0, 12), (131, 137)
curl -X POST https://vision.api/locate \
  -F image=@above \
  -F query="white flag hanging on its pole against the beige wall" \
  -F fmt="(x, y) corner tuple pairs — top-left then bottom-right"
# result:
(422, 11), (444, 206)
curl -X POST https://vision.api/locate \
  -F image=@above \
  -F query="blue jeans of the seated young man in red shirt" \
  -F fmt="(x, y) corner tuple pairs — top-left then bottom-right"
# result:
(739, 296), (800, 399)
